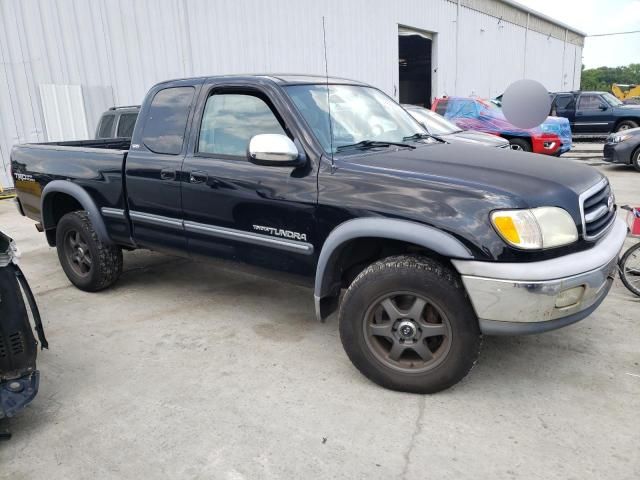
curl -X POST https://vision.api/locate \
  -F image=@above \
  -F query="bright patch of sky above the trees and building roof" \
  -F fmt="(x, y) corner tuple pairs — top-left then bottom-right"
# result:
(516, 0), (640, 68)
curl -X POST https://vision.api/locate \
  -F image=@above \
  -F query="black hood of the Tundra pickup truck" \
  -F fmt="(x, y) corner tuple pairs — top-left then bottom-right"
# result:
(342, 143), (603, 205)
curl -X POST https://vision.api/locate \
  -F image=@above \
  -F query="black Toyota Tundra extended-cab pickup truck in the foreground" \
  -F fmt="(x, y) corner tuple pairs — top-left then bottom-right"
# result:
(11, 75), (626, 392)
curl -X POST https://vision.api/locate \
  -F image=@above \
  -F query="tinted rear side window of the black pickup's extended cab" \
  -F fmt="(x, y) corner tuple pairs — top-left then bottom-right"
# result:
(142, 87), (195, 155)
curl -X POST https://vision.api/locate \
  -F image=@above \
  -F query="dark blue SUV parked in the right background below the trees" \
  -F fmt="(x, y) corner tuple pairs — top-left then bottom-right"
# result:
(551, 92), (640, 135)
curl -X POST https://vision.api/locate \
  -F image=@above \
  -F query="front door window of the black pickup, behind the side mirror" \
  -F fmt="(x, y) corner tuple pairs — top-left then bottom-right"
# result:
(198, 93), (286, 157)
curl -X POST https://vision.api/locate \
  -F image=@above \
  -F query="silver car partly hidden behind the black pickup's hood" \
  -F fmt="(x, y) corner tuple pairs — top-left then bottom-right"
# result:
(403, 105), (509, 148)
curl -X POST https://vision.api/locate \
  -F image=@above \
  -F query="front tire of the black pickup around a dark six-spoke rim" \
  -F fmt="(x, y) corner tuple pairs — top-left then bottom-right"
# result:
(339, 256), (482, 393)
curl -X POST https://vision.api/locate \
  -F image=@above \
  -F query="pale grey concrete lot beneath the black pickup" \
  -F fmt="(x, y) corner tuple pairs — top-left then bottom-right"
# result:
(0, 162), (640, 480)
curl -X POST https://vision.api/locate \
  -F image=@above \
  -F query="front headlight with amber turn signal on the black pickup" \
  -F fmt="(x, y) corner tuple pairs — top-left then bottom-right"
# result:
(491, 207), (578, 250)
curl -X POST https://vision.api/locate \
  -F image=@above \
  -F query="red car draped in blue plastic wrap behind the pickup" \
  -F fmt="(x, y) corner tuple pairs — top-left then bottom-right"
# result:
(431, 97), (571, 155)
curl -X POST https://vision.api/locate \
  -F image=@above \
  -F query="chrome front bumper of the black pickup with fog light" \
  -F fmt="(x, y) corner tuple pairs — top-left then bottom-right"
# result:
(453, 219), (627, 335)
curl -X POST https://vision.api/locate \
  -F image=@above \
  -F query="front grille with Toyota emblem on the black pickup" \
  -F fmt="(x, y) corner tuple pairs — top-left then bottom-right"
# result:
(580, 180), (616, 240)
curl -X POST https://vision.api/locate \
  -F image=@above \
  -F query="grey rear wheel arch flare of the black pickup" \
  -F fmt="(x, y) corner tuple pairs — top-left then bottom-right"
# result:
(40, 180), (113, 247)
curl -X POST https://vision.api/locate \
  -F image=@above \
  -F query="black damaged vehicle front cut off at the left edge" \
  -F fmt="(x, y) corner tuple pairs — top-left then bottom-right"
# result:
(0, 232), (48, 428)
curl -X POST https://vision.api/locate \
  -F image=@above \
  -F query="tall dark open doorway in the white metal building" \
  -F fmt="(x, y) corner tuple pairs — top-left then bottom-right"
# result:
(398, 27), (433, 108)
